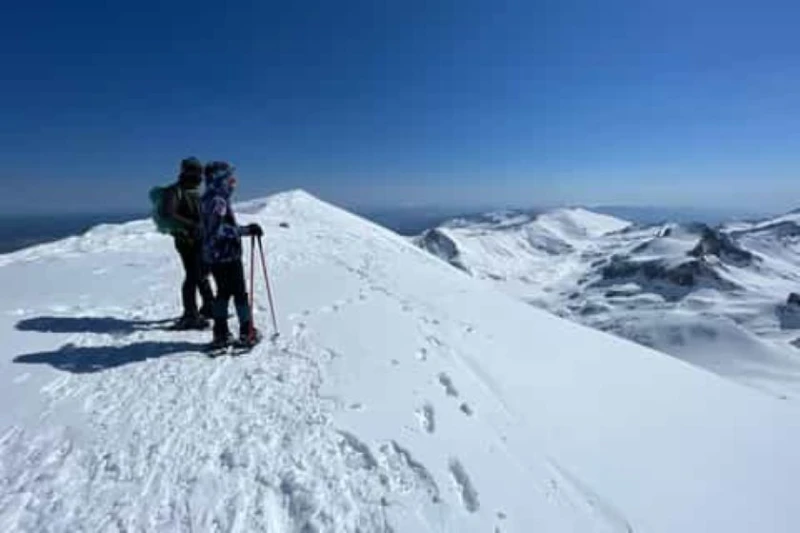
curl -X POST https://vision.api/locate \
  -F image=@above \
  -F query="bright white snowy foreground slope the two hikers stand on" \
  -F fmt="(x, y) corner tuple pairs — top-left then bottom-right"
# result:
(0, 192), (800, 533)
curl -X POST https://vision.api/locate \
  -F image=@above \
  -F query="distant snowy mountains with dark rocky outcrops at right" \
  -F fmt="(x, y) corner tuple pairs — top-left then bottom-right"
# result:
(414, 209), (800, 398)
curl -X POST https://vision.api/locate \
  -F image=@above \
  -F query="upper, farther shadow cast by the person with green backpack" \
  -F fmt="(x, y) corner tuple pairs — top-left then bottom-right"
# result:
(16, 316), (175, 335)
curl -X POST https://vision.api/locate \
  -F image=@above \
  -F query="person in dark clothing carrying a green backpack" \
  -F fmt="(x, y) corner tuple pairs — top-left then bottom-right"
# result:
(164, 157), (214, 329)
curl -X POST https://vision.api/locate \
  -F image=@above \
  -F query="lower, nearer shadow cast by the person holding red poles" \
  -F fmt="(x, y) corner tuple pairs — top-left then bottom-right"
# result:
(14, 342), (206, 374)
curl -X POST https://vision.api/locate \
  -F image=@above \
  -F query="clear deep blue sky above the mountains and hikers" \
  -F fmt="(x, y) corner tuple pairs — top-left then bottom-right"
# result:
(0, 0), (800, 212)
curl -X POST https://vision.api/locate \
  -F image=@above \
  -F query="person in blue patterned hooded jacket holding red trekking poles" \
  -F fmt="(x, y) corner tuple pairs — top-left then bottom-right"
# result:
(201, 161), (264, 348)
